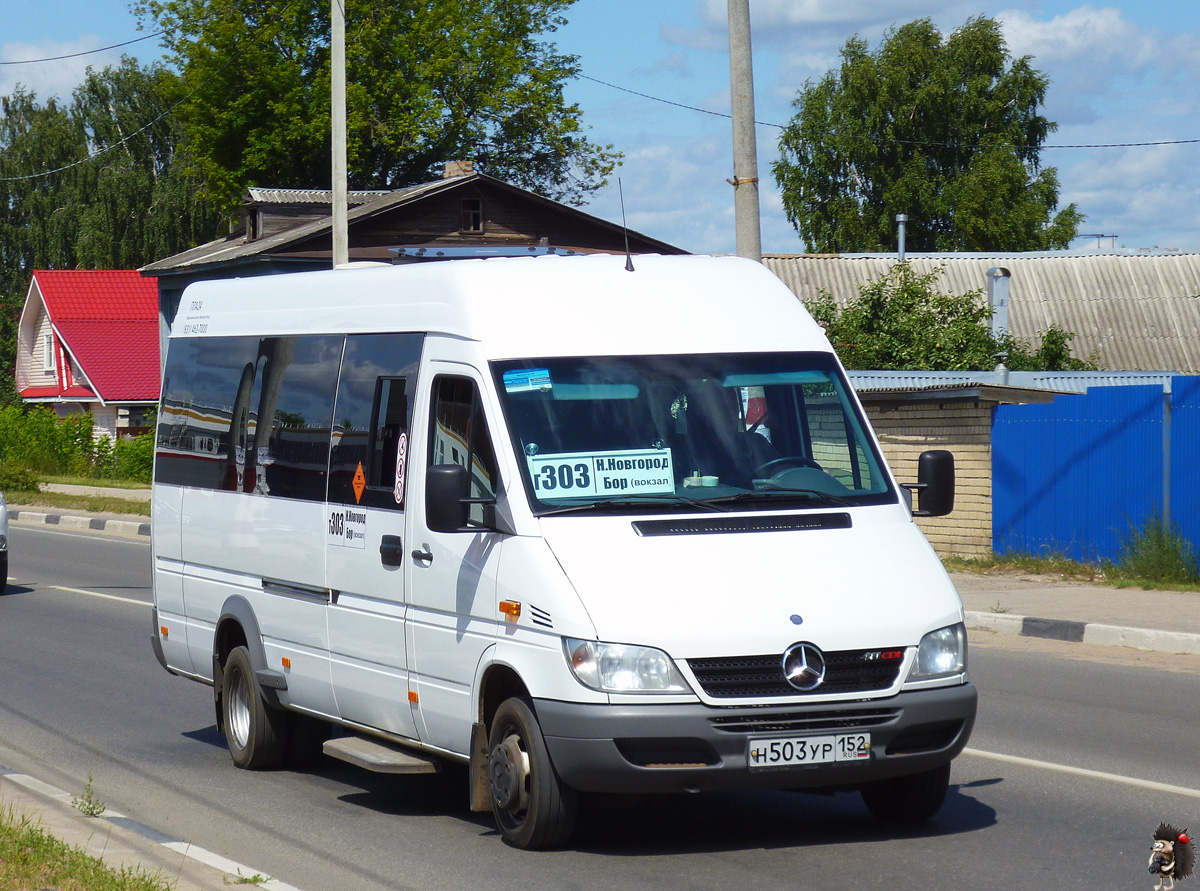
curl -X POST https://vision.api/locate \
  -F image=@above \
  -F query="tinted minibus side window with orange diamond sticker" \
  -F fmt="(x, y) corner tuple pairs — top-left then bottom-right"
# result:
(329, 334), (424, 509)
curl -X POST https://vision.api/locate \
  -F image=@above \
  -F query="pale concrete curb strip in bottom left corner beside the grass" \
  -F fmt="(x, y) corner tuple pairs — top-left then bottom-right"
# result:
(0, 766), (298, 891)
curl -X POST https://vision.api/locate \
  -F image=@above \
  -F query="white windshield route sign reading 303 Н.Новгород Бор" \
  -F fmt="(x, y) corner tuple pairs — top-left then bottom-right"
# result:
(527, 449), (676, 498)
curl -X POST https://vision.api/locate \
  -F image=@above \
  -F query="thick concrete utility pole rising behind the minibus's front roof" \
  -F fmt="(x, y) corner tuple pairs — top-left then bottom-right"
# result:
(728, 0), (762, 262)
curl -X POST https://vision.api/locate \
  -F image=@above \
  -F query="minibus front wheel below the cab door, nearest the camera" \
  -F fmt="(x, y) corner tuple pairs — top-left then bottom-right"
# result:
(487, 698), (578, 850)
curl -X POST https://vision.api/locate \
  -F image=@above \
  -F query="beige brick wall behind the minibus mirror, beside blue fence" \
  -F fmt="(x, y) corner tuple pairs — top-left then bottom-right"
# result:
(863, 394), (994, 556)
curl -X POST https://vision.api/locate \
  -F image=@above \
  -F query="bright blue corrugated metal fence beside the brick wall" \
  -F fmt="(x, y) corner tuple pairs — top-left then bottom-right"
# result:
(992, 377), (1200, 561)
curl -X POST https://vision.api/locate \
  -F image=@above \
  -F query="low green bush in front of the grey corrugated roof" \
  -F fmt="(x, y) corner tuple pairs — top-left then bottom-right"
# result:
(805, 263), (1096, 371)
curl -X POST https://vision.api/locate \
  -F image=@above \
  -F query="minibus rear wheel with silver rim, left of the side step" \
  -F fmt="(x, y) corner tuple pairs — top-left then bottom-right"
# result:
(221, 646), (289, 770)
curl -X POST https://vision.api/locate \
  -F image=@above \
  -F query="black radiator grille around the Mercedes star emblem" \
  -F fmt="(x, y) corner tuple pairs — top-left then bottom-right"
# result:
(688, 647), (904, 699)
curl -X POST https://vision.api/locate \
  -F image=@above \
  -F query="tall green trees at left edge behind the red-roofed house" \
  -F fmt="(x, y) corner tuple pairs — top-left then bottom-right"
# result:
(0, 59), (221, 403)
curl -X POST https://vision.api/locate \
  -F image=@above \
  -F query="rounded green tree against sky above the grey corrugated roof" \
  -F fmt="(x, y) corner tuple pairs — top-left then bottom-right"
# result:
(773, 18), (1084, 252)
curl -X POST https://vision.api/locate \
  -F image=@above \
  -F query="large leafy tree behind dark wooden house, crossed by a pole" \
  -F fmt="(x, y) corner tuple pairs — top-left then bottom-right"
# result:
(134, 0), (619, 209)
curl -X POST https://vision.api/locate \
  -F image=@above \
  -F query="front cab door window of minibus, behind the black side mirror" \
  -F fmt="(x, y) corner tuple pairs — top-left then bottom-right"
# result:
(430, 377), (499, 522)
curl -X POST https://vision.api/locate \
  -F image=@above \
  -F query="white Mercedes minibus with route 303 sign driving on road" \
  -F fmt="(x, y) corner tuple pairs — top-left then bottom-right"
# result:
(152, 256), (976, 848)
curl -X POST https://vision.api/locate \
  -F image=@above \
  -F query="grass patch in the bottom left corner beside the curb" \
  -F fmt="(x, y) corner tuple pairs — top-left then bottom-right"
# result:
(0, 808), (173, 891)
